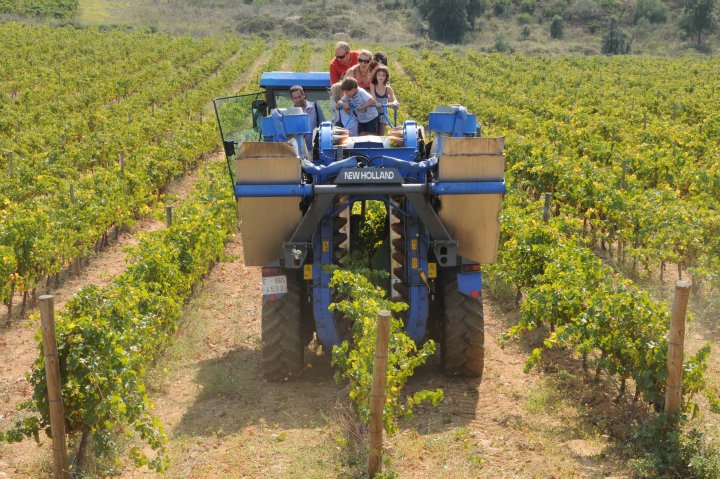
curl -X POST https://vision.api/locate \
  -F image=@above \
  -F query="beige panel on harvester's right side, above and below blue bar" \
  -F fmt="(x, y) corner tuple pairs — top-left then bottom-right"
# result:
(438, 137), (505, 264)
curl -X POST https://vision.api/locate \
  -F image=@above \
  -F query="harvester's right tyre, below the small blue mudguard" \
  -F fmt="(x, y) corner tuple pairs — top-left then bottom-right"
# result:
(440, 272), (485, 378)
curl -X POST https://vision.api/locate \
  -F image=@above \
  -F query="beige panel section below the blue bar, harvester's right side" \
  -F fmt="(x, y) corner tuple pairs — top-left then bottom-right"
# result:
(438, 195), (502, 264)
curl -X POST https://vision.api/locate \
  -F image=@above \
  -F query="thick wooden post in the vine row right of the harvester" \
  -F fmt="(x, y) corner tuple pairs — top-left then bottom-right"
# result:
(665, 281), (690, 414)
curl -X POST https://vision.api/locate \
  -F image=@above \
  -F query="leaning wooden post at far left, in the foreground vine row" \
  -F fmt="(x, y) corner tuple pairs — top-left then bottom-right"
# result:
(40, 295), (69, 479)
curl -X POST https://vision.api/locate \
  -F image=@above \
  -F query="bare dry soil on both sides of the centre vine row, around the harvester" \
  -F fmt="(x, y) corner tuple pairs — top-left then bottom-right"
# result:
(97, 237), (629, 479)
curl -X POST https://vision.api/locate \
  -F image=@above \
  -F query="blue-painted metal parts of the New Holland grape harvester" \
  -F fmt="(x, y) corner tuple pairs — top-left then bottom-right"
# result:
(226, 99), (505, 348)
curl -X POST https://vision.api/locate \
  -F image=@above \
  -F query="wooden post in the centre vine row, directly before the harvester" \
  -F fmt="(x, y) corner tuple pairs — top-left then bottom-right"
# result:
(368, 310), (390, 478)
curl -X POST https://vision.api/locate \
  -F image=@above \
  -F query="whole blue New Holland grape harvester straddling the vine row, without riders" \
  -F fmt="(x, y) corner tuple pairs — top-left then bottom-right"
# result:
(215, 72), (505, 380)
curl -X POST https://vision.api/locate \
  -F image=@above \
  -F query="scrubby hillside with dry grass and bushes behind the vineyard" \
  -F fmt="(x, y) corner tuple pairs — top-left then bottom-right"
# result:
(0, 0), (720, 55)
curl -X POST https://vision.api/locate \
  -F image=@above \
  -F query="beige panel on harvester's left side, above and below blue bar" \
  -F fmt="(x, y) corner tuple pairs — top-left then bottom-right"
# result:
(235, 141), (302, 266)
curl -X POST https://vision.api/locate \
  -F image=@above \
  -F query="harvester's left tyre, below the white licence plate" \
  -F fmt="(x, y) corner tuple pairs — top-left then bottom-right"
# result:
(262, 271), (307, 381)
